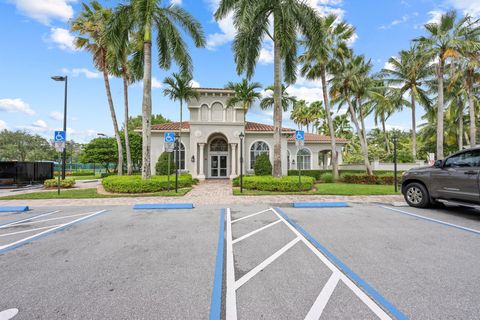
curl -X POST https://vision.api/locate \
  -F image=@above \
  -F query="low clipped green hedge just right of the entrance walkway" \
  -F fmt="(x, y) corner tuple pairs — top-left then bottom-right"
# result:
(233, 176), (315, 192)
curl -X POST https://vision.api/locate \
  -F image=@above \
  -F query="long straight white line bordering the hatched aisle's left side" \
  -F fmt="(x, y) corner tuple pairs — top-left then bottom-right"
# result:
(225, 208), (237, 320)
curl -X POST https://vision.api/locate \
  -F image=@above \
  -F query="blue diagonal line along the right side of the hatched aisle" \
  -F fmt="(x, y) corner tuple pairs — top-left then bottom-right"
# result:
(275, 208), (408, 320)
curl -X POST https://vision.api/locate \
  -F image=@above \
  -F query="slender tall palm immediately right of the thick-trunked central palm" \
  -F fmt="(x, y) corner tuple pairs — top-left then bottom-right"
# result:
(299, 15), (355, 180)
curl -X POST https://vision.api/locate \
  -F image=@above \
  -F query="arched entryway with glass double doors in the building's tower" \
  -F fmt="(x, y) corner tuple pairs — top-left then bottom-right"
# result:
(207, 134), (230, 179)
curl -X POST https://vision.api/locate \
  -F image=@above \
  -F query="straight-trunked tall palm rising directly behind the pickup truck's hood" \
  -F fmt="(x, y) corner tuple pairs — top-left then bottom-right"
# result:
(415, 11), (468, 159)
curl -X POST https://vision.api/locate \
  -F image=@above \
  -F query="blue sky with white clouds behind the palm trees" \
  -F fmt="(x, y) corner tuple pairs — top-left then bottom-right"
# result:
(0, 0), (480, 142)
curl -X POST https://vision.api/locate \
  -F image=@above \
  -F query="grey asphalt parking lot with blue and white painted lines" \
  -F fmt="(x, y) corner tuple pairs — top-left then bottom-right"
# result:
(0, 204), (480, 320)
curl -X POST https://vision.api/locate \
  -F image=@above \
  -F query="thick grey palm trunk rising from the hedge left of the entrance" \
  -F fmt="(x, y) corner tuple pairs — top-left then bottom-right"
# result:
(142, 37), (152, 179)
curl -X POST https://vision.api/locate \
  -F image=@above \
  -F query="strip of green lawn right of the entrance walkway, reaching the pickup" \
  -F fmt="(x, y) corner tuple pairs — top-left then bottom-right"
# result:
(233, 183), (400, 196)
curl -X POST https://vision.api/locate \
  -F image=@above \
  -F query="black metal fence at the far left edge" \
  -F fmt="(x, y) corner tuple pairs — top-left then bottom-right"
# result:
(0, 161), (54, 186)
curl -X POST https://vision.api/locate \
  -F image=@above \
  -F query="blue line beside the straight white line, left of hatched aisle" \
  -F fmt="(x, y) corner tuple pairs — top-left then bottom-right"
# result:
(209, 209), (225, 320)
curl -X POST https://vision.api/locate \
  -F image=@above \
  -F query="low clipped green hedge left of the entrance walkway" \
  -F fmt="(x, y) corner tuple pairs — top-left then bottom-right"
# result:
(102, 174), (193, 193)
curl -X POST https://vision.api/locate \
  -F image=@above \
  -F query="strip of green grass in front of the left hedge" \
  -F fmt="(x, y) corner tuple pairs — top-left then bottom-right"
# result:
(0, 188), (192, 200)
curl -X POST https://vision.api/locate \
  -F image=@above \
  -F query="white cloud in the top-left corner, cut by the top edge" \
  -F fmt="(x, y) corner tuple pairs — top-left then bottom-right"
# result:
(11, 0), (75, 25)
